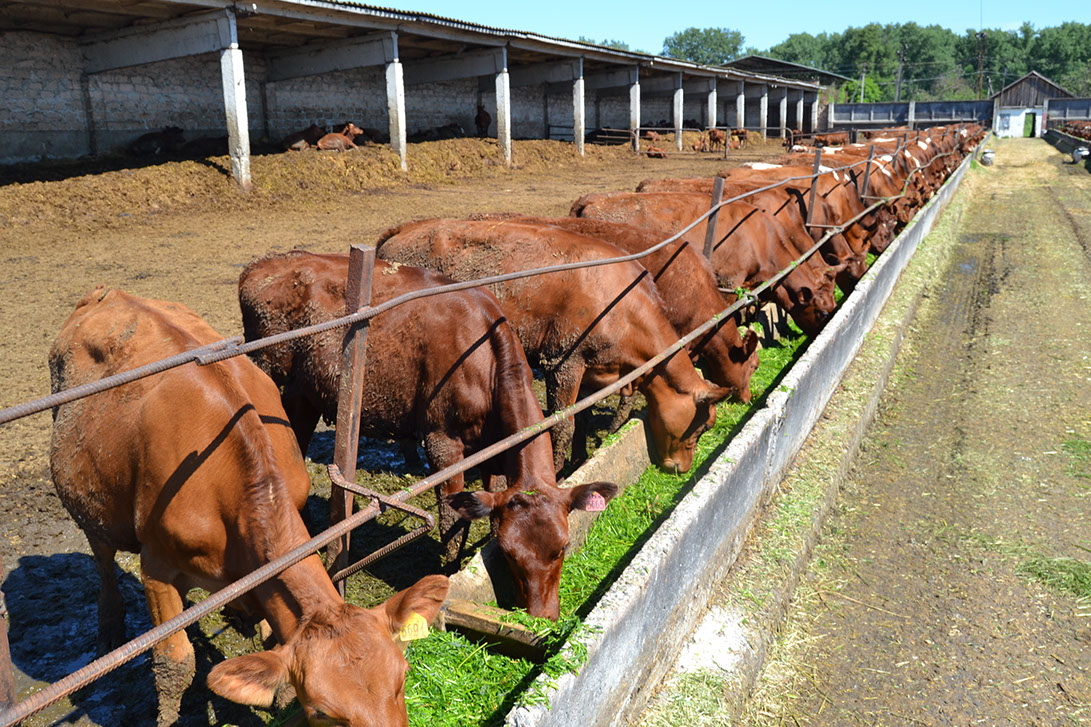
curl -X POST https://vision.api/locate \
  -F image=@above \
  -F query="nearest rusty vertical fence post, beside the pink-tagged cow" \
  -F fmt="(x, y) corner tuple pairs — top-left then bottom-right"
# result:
(326, 245), (375, 596)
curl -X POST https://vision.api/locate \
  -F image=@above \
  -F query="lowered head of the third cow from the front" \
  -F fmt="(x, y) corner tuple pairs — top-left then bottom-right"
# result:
(644, 376), (732, 473)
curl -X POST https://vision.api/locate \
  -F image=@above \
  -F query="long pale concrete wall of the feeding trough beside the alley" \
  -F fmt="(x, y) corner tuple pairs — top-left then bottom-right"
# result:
(505, 148), (972, 727)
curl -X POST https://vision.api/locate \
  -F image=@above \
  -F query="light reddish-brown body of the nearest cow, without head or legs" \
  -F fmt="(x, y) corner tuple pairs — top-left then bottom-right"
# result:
(49, 289), (309, 556)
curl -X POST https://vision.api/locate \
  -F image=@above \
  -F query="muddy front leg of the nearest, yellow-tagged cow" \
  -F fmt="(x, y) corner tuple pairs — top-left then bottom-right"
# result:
(141, 549), (196, 727)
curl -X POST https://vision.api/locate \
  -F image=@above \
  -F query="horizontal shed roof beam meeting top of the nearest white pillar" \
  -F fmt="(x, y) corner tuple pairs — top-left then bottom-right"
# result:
(81, 10), (238, 73)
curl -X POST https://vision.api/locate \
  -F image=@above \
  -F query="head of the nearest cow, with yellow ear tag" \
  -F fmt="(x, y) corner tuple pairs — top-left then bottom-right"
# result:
(208, 575), (448, 727)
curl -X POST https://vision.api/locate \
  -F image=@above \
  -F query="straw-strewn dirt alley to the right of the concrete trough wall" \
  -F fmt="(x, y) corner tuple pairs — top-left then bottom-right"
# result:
(743, 140), (1091, 726)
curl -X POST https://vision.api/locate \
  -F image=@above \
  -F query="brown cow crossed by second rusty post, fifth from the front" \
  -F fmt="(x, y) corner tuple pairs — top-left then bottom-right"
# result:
(572, 187), (837, 335)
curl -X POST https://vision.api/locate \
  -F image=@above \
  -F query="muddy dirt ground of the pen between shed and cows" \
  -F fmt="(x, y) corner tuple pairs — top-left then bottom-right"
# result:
(0, 134), (781, 724)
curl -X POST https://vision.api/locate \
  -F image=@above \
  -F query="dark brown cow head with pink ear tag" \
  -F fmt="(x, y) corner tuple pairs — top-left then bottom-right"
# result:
(447, 482), (618, 621)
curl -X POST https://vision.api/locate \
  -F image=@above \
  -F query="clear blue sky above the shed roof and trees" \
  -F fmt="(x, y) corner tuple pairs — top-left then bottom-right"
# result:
(399, 0), (1091, 53)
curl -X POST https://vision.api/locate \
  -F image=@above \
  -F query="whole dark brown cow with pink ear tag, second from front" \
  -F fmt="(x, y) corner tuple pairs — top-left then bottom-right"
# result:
(239, 250), (616, 619)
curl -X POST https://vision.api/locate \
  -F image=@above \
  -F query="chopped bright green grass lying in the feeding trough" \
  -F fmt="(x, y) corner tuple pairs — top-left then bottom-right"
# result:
(406, 329), (806, 727)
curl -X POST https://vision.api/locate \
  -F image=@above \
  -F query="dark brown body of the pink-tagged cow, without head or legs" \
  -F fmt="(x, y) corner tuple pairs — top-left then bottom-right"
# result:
(239, 251), (530, 446)
